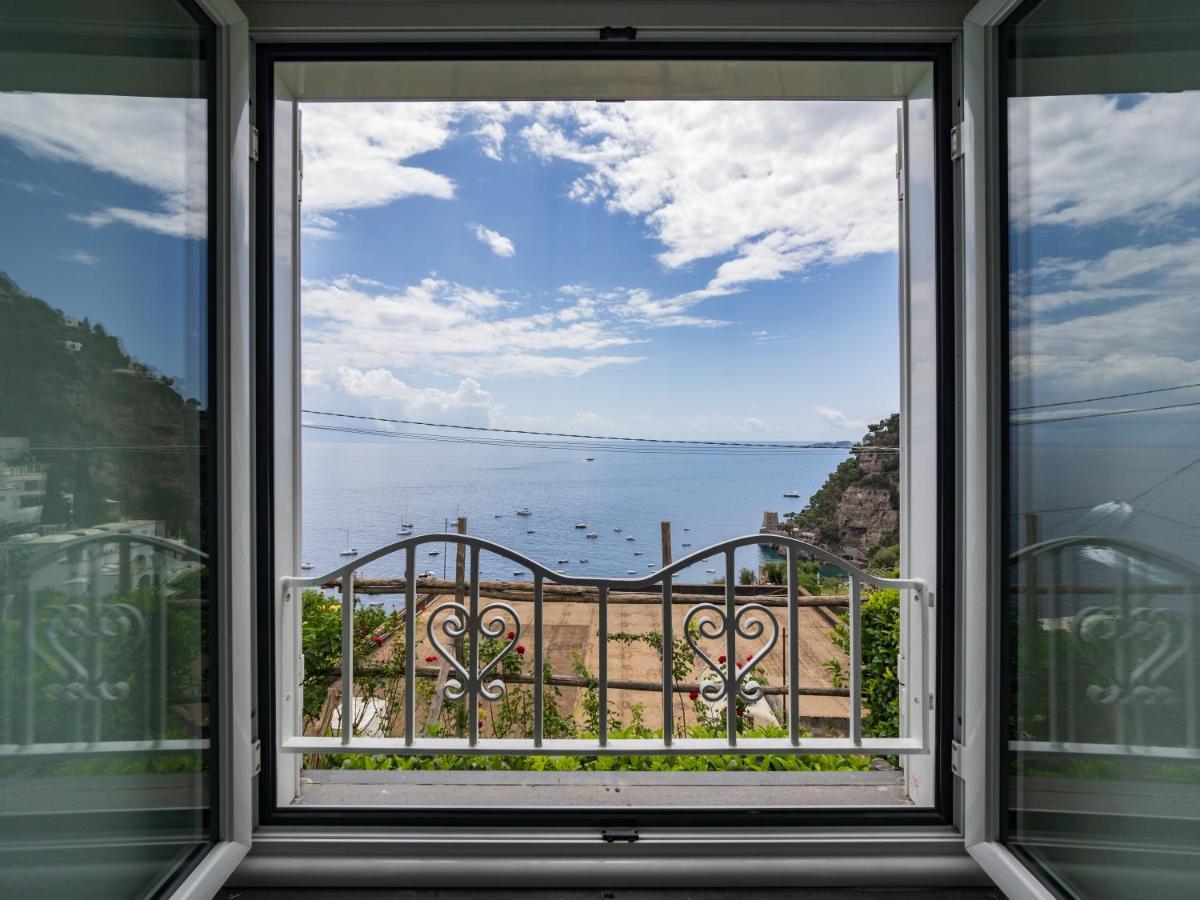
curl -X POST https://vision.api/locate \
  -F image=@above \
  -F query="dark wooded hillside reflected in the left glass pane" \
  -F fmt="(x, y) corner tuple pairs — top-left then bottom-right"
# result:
(0, 272), (205, 546)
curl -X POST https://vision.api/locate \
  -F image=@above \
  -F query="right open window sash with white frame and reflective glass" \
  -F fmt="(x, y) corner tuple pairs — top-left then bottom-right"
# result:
(960, 0), (1200, 896)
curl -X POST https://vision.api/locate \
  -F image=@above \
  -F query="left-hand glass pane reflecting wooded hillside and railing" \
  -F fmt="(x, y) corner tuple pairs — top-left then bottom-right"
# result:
(0, 0), (214, 898)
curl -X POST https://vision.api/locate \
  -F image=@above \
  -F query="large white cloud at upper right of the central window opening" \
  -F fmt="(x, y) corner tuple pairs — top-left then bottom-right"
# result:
(521, 101), (896, 296)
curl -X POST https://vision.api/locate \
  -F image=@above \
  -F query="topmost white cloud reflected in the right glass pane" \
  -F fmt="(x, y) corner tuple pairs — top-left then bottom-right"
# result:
(1009, 91), (1200, 227)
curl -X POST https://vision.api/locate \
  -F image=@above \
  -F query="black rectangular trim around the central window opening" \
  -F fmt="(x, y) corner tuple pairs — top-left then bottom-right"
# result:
(254, 40), (958, 828)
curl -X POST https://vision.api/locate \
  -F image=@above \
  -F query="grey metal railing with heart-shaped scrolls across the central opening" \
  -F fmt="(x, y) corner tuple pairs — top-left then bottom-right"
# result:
(277, 534), (931, 756)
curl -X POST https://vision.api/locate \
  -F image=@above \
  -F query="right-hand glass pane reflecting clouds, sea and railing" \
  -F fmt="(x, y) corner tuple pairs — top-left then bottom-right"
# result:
(1006, 0), (1200, 898)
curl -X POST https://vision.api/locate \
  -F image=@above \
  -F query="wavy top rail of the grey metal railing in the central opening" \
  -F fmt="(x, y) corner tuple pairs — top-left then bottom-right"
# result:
(283, 533), (925, 592)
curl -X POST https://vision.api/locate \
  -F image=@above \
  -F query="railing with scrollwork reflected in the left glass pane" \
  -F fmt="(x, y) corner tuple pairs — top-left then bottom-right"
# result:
(0, 533), (209, 757)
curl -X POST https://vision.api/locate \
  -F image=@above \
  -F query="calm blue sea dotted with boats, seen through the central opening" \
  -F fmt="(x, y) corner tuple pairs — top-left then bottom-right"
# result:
(302, 436), (848, 595)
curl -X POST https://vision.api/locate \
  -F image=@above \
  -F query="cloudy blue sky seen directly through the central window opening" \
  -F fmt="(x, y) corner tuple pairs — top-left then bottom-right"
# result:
(302, 102), (899, 439)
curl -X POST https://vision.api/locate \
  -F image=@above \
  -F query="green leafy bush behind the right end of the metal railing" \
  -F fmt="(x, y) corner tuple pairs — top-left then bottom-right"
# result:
(826, 589), (900, 738)
